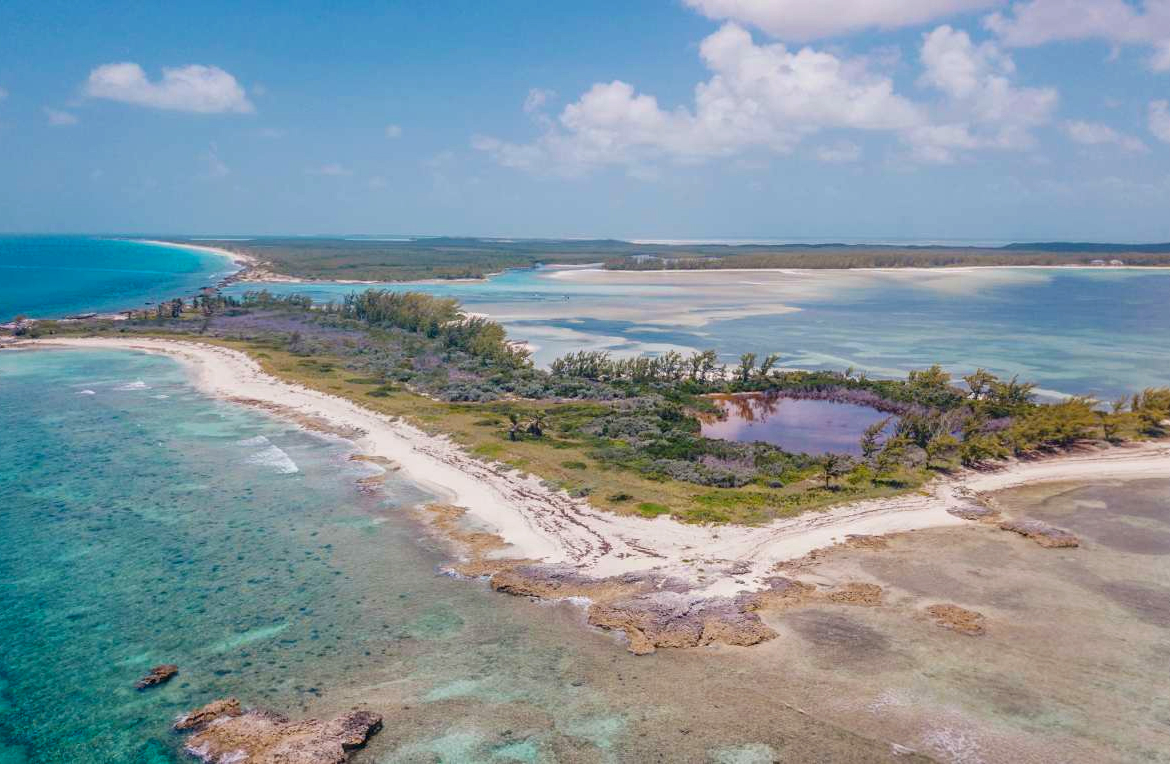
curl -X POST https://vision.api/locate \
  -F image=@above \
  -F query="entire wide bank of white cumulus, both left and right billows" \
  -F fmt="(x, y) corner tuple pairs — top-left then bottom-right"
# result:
(472, 23), (1059, 177)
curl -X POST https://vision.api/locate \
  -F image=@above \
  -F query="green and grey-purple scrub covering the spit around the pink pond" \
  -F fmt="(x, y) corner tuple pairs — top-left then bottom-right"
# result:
(19, 290), (1170, 523)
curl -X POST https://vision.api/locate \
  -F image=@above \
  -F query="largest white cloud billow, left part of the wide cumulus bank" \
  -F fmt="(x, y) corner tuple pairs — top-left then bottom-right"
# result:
(472, 23), (923, 175)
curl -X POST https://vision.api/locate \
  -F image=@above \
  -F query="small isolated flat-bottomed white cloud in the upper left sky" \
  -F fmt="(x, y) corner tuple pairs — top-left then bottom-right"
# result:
(85, 62), (254, 113)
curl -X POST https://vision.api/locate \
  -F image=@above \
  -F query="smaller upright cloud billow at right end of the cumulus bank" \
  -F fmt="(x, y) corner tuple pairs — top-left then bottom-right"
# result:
(908, 25), (1060, 161)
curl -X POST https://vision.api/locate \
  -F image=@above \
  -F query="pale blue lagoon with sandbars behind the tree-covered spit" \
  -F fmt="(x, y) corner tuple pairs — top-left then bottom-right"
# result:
(225, 268), (1170, 398)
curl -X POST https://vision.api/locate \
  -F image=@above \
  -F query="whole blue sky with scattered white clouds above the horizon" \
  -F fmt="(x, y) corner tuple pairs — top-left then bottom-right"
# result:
(0, 0), (1170, 242)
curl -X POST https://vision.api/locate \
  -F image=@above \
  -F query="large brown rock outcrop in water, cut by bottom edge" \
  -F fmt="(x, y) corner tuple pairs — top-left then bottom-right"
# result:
(176, 697), (381, 764)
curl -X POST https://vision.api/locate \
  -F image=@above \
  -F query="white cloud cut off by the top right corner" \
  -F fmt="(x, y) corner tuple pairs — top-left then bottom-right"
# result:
(985, 0), (1170, 71)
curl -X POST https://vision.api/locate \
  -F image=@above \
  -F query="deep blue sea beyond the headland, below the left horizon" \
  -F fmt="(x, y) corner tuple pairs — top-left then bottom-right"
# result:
(0, 236), (234, 322)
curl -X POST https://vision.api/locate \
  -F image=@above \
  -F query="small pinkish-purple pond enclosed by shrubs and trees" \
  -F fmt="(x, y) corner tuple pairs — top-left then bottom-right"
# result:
(702, 394), (889, 455)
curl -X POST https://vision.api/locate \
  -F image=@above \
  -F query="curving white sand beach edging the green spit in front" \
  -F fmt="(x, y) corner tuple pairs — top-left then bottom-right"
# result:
(18, 337), (1170, 596)
